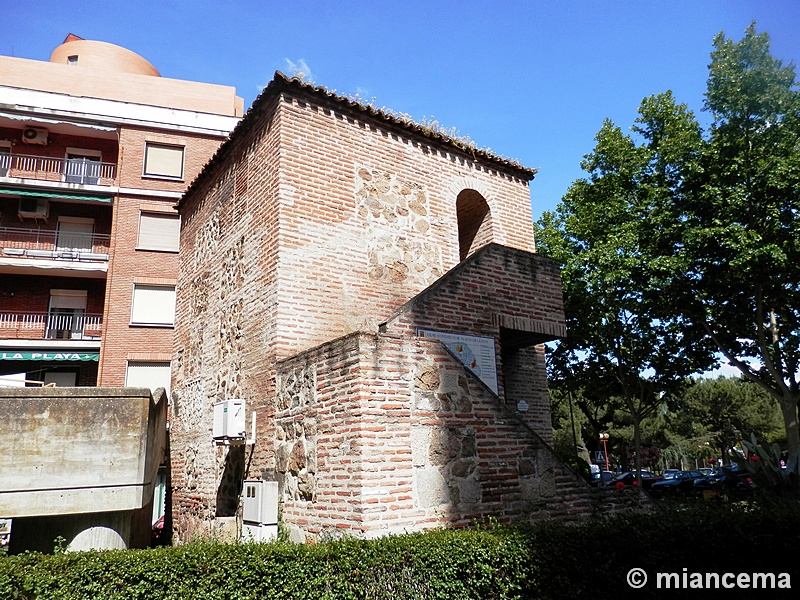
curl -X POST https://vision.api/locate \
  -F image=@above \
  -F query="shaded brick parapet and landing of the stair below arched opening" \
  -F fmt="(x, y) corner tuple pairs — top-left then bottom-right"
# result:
(381, 245), (565, 443)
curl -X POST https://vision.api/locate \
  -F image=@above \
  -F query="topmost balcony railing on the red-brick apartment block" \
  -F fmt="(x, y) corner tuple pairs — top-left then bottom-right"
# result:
(0, 152), (117, 185)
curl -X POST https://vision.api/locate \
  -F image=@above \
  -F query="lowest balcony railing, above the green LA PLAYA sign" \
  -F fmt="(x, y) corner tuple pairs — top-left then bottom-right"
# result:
(0, 308), (103, 340)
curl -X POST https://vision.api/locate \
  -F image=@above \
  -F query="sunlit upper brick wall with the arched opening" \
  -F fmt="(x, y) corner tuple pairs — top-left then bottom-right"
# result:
(278, 90), (533, 356)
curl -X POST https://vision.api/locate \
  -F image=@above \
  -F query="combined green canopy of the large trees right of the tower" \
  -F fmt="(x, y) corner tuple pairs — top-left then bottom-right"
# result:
(538, 25), (800, 464)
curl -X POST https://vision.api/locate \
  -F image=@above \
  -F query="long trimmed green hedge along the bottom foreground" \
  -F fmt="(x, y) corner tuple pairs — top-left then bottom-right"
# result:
(0, 503), (800, 600)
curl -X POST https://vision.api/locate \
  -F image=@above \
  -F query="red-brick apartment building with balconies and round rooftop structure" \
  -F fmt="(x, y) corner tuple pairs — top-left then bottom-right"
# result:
(0, 34), (243, 390)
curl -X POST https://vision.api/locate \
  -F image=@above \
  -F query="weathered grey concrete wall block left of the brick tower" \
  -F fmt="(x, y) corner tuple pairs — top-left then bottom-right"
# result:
(0, 388), (166, 518)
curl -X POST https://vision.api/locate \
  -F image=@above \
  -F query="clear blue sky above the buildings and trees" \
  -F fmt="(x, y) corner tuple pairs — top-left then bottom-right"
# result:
(0, 0), (800, 219)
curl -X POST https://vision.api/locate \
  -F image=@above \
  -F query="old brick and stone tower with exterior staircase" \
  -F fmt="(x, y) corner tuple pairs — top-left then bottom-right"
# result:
(170, 73), (612, 541)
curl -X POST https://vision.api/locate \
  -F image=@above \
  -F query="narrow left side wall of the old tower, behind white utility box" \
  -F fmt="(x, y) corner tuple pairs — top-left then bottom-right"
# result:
(171, 96), (280, 540)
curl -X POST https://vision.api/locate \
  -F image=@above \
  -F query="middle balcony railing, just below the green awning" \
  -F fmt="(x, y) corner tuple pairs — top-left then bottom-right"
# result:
(0, 227), (111, 262)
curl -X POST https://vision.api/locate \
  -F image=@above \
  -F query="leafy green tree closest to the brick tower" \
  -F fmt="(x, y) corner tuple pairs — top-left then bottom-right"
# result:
(538, 93), (711, 482)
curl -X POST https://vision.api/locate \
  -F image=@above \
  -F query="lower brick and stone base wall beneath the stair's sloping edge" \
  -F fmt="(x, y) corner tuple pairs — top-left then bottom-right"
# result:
(268, 333), (641, 541)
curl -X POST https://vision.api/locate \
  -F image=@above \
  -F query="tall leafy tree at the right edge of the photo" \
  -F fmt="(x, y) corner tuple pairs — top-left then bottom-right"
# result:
(643, 25), (800, 457)
